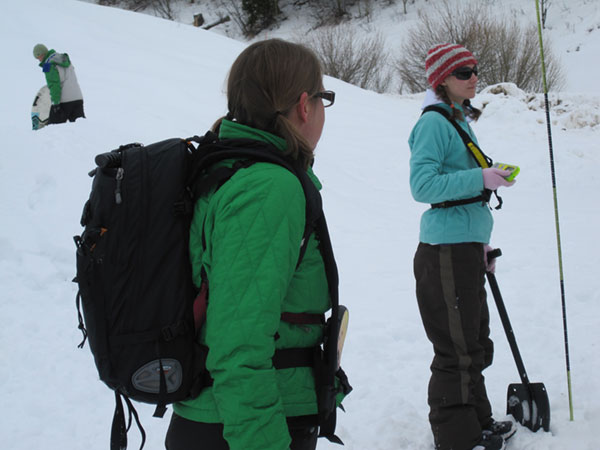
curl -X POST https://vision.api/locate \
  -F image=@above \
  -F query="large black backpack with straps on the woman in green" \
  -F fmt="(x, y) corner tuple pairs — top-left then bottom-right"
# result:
(74, 132), (351, 450)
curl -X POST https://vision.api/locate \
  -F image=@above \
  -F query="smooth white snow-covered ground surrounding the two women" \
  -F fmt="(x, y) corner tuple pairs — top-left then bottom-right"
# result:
(0, 0), (600, 450)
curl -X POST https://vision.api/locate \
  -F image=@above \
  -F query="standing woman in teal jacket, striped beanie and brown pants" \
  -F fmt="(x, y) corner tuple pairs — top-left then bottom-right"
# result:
(409, 44), (515, 450)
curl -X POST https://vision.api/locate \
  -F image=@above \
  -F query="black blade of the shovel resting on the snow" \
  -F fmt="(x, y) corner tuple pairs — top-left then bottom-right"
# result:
(506, 383), (550, 432)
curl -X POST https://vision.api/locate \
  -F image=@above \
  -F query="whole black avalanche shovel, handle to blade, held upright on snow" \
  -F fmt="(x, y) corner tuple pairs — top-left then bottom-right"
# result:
(486, 248), (550, 431)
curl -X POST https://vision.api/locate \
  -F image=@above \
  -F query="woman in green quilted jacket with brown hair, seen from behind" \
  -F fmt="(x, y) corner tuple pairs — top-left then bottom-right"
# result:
(166, 39), (342, 450)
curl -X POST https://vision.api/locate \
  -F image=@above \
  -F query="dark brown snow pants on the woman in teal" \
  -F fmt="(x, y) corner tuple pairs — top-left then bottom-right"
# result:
(414, 243), (494, 450)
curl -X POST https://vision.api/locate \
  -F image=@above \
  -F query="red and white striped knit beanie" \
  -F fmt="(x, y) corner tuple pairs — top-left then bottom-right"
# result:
(425, 44), (477, 90)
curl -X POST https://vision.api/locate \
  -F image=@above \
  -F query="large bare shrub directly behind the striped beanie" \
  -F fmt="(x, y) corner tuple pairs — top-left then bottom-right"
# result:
(395, 0), (564, 92)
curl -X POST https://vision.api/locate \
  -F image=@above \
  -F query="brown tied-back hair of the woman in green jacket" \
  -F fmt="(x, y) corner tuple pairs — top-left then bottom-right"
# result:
(213, 39), (323, 168)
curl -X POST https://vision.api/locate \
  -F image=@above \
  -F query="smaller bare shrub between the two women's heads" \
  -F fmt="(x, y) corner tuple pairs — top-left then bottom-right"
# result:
(302, 25), (392, 92)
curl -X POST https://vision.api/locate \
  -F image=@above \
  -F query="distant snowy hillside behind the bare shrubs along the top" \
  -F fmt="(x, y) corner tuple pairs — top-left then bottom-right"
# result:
(81, 0), (600, 93)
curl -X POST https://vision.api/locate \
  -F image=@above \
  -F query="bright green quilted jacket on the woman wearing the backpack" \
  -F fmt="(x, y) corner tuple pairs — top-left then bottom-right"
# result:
(174, 120), (330, 450)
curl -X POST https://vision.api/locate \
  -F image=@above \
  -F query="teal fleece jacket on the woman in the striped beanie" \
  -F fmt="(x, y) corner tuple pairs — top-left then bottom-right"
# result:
(408, 103), (493, 244)
